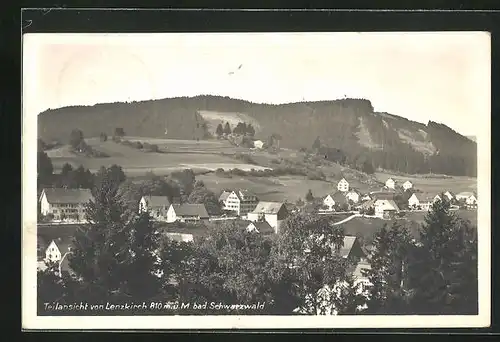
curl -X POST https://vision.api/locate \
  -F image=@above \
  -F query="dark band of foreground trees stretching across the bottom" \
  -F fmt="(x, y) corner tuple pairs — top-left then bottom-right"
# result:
(38, 166), (477, 315)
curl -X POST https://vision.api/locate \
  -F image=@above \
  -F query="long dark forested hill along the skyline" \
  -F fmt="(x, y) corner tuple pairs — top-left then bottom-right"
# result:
(38, 96), (477, 176)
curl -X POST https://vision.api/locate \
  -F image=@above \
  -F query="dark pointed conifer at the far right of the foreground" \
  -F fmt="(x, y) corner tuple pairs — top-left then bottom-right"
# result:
(411, 200), (478, 314)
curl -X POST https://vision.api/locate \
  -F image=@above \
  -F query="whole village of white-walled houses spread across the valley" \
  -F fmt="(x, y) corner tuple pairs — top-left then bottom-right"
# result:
(38, 174), (478, 292)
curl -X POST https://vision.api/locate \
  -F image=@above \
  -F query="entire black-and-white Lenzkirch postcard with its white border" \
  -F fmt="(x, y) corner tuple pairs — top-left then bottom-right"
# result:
(22, 32), (491, 329)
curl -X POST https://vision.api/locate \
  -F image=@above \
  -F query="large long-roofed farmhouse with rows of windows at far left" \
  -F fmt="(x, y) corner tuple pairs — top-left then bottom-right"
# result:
(39, 188), (92, 222)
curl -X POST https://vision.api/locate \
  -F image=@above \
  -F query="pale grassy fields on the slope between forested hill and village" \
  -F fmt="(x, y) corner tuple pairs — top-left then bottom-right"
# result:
(47, 136), (477, 202)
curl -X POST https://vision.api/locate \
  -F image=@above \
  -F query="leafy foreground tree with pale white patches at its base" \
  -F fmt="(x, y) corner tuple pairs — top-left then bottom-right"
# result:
(268, 214), (360, 315)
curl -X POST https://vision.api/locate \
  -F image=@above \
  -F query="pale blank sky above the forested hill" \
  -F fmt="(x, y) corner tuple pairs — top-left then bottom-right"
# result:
(23, 32), (491, 135)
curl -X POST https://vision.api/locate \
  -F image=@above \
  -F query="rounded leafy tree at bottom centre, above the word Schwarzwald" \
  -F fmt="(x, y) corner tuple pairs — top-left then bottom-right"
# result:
(170, 222), (272, 314)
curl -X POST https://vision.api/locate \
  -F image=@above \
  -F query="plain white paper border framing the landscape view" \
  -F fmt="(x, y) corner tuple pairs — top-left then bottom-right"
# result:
(21, 32), (491, 330)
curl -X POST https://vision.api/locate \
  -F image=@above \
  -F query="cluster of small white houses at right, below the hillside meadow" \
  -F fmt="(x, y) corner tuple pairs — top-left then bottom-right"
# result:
(319, 178), (477, 218)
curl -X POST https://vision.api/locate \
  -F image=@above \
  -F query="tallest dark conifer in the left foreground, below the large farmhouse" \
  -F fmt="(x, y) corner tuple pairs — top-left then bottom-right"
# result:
(68, 167), (161, 303)
